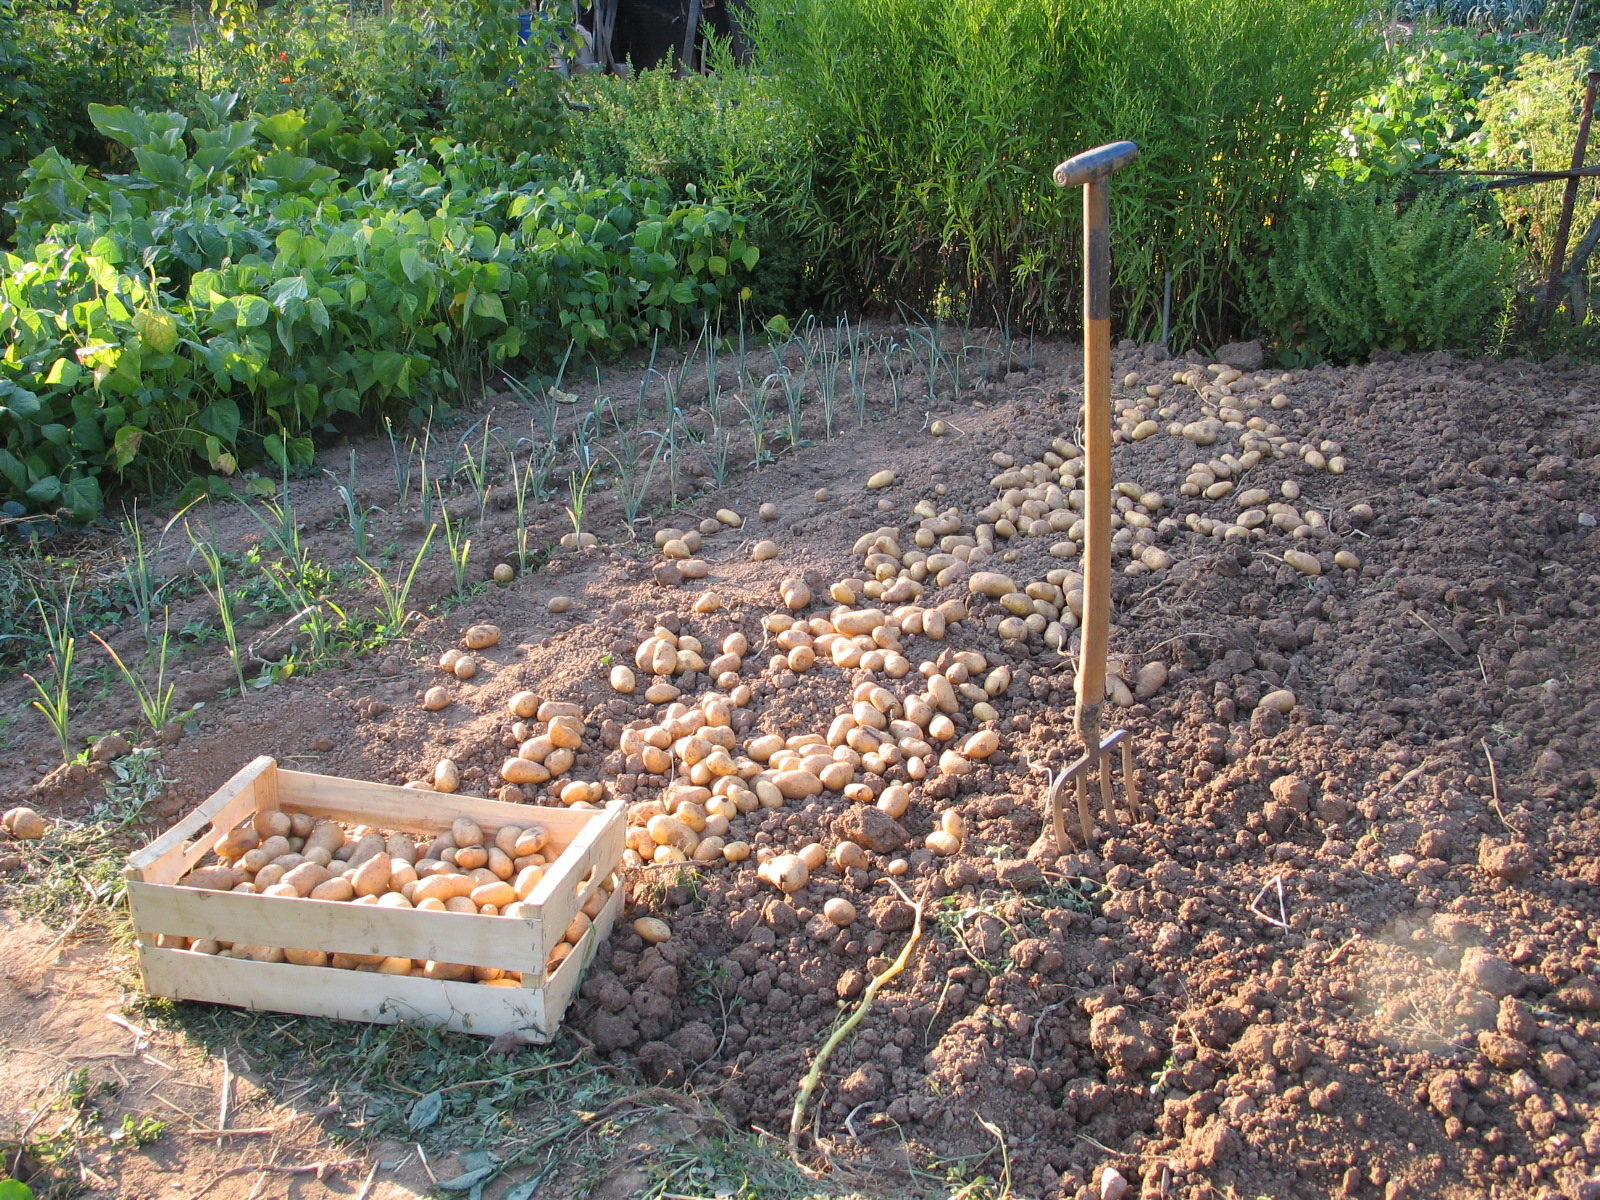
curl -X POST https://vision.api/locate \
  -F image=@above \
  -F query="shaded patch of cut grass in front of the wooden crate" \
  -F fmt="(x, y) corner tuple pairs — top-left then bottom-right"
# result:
(142, 1000), (814, 1200)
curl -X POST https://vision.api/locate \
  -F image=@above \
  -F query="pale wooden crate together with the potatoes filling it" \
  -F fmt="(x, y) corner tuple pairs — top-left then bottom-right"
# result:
(125, 757), (626, 1042)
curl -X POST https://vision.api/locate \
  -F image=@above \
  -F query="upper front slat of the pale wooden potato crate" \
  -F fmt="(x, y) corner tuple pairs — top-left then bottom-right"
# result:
(128, 882), (550, 974)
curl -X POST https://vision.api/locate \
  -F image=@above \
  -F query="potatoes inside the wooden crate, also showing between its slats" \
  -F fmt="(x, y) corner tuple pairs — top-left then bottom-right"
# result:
(157, 811), (616, 987)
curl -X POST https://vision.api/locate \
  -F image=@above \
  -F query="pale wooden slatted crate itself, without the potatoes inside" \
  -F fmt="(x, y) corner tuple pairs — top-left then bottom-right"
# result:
(123, 757), (626, 1042)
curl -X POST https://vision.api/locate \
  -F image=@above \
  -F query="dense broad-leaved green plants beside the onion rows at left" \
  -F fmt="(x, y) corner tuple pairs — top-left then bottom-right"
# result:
(0, 102), (760, 517)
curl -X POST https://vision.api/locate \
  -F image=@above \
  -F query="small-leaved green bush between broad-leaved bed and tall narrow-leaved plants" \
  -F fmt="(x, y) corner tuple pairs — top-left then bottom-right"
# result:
(555, 61), (832, 314)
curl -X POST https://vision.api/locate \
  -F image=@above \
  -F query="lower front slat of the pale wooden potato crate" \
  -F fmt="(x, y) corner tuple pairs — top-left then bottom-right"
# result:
(139, 947), (560, 1042)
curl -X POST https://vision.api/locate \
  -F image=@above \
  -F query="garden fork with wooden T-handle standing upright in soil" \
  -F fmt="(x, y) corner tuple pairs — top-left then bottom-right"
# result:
(1050, 142), (1141, 853)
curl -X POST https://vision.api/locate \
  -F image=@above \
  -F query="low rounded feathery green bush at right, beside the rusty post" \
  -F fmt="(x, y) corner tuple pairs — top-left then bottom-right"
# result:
(1251, 189), (1512, 362)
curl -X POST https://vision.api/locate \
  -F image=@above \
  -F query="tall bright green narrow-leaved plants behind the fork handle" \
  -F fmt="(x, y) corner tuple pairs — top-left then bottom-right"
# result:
(747, 0), (1381, 341)
